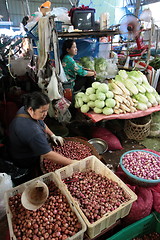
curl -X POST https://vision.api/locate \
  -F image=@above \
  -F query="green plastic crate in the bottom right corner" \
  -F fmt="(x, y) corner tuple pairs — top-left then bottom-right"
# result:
(106, 212), (160, 240)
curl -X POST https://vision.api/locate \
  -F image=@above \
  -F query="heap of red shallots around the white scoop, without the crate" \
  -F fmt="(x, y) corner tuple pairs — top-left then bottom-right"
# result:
(9, 182), (82, 240)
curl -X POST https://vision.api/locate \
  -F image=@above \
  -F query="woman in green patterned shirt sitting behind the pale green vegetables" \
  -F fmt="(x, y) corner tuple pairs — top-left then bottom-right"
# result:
(61, 39), (96, 92)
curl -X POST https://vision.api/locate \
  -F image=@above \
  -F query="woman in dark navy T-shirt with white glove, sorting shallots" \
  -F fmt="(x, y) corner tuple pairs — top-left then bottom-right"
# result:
(9, 92), (74, 172)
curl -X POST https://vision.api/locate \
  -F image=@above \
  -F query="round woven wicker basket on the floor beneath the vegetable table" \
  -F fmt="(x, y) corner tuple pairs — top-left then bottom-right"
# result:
(124, 118), (152, 140)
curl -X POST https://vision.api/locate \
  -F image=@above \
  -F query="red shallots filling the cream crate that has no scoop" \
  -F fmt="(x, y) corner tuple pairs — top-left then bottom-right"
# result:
(63, 170), (130, 223)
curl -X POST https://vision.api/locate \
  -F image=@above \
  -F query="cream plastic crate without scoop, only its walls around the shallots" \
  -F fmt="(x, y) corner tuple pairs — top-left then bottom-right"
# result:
(55, 156), (137, 239)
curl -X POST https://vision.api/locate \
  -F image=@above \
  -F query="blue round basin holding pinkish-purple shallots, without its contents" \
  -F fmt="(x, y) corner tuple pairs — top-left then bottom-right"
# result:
(120, 150), (160, 187)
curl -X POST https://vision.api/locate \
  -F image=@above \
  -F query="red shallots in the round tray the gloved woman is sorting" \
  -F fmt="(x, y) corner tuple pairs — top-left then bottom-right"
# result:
(43, 141), (92, 172)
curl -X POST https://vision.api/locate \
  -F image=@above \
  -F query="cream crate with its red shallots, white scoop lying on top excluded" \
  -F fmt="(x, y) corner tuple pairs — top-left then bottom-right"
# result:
(5, 173), (86, 240)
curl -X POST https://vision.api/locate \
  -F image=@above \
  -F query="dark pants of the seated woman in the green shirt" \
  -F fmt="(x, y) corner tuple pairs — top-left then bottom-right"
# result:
(74, 76), (95, 92)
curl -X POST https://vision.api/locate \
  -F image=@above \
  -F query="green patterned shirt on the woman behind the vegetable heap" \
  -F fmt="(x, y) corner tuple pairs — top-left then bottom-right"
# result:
(62, 55), (87, 87)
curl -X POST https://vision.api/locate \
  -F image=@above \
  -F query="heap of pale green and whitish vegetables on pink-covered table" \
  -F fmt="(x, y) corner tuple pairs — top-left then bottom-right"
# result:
(75, 70), (160, 115)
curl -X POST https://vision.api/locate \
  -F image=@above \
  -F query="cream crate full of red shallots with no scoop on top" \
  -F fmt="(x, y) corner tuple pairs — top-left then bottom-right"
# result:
(55, 156), (137, 239)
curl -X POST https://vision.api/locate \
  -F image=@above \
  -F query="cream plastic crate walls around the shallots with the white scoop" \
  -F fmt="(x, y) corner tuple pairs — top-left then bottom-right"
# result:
(4, 173), (86, 240)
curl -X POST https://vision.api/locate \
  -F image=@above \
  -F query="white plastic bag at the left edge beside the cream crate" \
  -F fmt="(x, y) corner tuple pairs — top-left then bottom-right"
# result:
(0, 173), (13, 219)
